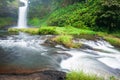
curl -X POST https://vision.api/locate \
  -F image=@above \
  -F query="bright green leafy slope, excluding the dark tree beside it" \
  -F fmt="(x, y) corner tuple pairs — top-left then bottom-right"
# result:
(48, 2), (96, 28)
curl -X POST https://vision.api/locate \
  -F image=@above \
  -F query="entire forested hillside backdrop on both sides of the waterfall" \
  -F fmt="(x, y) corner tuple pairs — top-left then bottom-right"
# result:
(0, 0), (120, 32)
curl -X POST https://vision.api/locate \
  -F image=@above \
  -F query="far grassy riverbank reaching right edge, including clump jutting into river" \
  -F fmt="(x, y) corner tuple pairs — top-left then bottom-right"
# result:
(8, 26), (120, 47)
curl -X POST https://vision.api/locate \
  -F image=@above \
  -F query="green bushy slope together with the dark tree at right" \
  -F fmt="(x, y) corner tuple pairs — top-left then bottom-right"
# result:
(47, 0), (120, 32)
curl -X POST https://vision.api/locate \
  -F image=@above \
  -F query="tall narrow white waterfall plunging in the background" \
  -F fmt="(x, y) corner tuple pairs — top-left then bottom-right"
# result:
(18, 0), (28, 28)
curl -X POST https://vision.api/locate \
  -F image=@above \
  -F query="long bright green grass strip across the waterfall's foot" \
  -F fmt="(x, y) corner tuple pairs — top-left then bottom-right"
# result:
(8, 26), (96, 35)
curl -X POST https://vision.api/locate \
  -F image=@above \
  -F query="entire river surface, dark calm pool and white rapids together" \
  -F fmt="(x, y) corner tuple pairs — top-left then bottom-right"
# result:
(0, 33), (120, 78)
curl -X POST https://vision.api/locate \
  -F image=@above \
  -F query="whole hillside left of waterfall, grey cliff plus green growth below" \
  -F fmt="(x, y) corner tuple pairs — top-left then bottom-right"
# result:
(0, 0), (19, 28)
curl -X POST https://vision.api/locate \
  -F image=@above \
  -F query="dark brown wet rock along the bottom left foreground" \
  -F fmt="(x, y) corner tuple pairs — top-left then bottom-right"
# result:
(0, 70), (66, 80)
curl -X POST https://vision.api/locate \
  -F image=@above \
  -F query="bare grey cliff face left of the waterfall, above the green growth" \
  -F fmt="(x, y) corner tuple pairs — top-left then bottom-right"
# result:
(0, 0), (18, 17)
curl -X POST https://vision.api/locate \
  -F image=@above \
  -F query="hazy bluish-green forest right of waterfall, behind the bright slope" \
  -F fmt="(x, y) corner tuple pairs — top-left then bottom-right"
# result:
(29, 0), (85, 17)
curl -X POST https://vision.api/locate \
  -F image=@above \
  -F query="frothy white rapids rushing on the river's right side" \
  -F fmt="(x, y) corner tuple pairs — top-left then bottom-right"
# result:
(61, 39), (120, 78)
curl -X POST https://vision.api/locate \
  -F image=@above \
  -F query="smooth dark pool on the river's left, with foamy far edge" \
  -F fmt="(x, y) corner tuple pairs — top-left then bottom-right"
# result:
(0, 33), (60, 73)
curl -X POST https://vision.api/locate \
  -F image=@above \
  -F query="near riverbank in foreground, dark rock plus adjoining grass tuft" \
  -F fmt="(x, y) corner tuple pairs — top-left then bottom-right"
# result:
(0, 70), (106, 80)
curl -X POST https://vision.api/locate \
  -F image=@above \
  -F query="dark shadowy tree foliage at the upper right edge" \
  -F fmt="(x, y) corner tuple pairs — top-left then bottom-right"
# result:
(96, 0), (120, 33)
